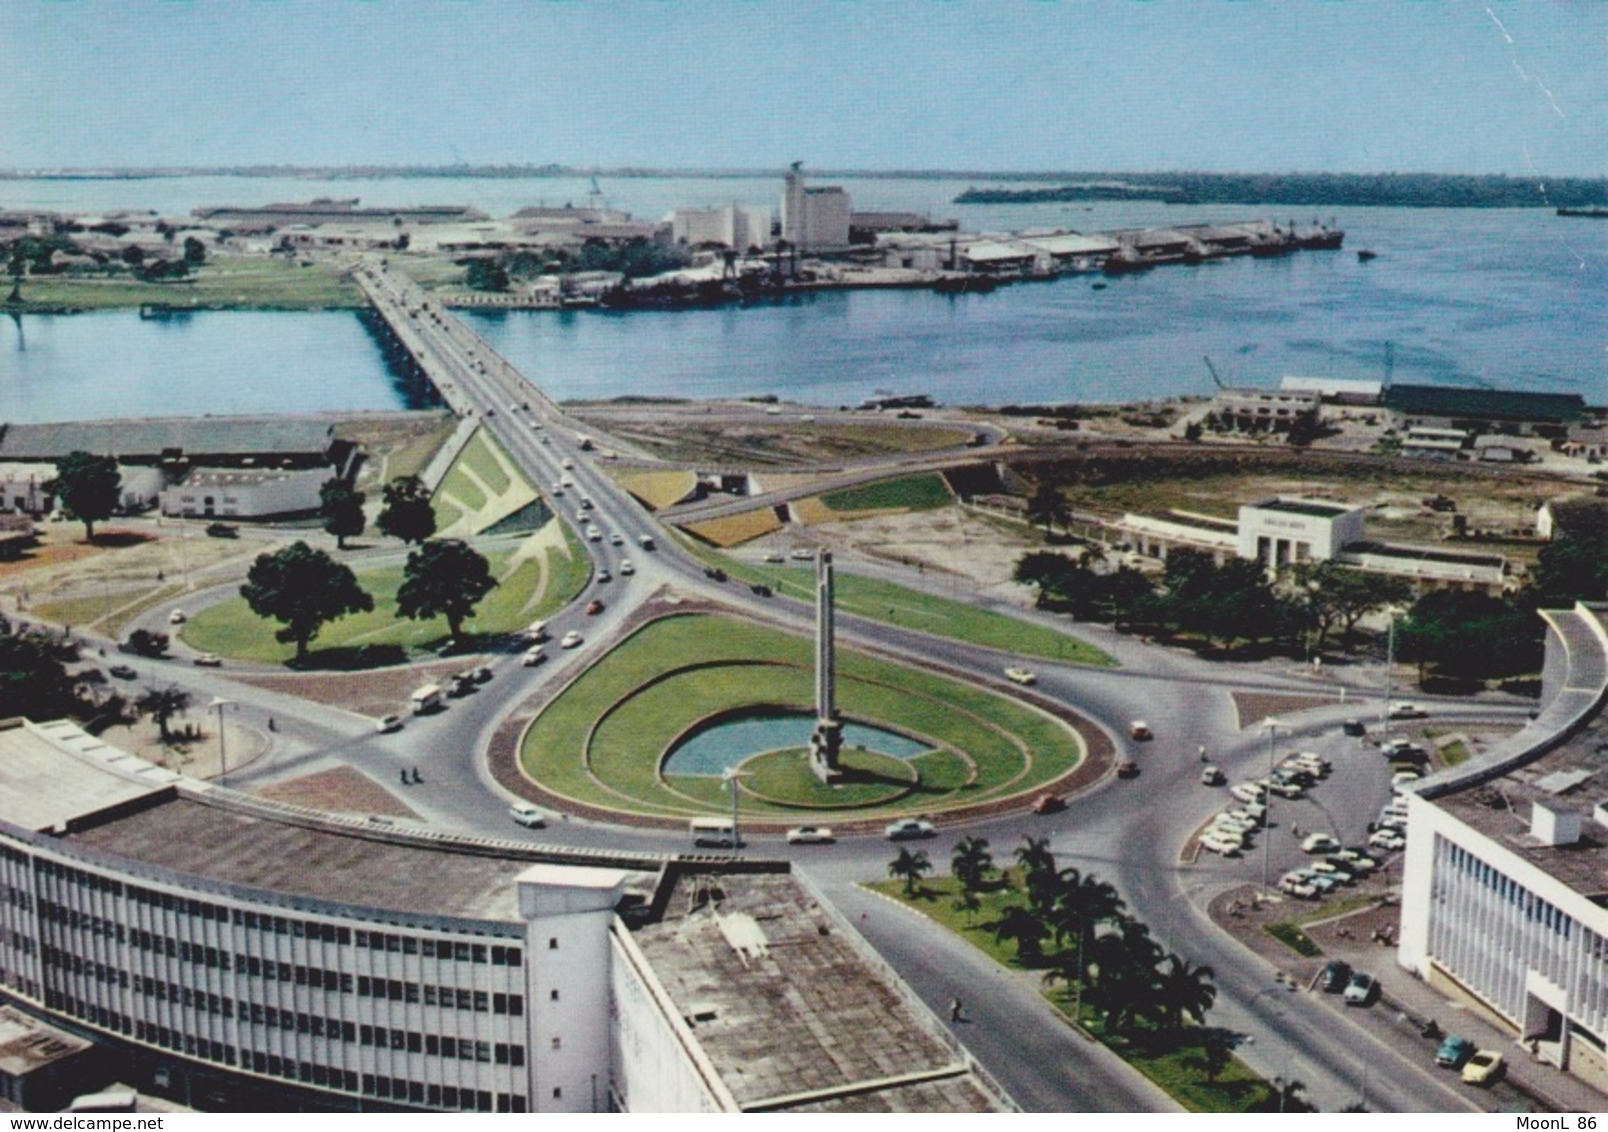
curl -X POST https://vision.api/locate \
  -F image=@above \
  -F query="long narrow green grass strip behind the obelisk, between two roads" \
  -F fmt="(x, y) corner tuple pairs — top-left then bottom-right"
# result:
(683, 540), (1116, 667)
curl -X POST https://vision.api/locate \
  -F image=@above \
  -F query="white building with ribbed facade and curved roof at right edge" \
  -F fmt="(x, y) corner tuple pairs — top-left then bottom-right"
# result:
(1399, 605), (1608, 1092)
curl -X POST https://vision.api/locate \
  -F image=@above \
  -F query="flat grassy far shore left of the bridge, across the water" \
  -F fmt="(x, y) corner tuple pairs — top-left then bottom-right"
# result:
(9, 249), (367, 310)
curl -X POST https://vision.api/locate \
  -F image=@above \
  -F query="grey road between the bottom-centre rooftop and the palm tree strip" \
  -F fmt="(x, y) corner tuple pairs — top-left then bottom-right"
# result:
(822, 883), (1179, 1113)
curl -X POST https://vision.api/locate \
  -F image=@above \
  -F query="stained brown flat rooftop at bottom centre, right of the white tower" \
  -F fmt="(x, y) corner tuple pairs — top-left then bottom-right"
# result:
(632, 873), (1002, 1113)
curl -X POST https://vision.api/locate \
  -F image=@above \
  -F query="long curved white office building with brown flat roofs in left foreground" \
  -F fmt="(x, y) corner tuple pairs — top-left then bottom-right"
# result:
(0, 720), (1011, 1113)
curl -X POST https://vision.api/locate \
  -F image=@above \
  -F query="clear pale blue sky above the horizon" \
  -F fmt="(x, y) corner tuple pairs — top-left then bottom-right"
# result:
(0, 0), (1608, 177)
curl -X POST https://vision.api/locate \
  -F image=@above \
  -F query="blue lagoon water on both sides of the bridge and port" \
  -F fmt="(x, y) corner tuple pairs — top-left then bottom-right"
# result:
(0, 178), (1608, 420)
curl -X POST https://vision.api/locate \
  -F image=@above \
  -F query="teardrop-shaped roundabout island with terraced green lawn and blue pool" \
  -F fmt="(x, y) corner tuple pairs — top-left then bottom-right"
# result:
(519, 614), (1085, 826)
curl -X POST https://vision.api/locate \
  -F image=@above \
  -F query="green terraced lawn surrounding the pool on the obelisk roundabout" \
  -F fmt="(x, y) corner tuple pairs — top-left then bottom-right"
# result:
(521, 616), (1082, 817)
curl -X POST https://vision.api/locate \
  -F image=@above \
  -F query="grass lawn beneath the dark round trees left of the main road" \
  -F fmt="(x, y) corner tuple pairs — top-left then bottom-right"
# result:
(180, 524), (587, 664)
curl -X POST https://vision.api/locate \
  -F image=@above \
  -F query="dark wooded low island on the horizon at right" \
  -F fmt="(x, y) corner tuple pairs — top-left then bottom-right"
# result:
(955, 174), (1608, 209)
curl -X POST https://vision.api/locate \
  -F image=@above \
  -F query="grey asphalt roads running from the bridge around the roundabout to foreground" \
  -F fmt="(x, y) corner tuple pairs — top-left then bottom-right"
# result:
(110, 265), (1517, 1111)
